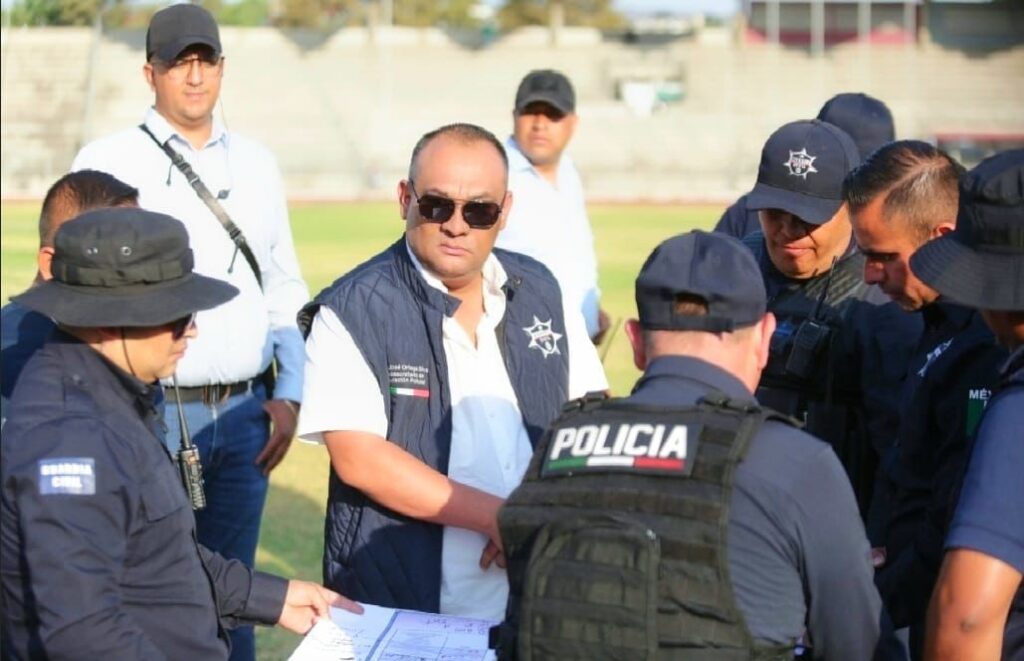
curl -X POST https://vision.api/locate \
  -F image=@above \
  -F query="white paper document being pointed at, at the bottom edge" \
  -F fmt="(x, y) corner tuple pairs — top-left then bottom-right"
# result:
(290, 604), (497, 661)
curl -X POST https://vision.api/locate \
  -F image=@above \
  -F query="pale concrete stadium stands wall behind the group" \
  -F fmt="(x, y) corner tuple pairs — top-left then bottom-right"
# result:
(0, 29), (1024, 201)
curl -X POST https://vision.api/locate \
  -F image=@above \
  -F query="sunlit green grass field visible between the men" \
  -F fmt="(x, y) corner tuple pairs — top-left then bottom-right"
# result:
(0, 203), (721, 660)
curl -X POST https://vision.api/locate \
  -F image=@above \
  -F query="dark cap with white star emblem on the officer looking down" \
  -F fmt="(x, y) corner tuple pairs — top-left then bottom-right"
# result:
(746, 120), (860, 225)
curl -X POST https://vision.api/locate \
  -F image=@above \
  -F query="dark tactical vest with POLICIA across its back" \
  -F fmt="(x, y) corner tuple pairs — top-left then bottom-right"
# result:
(492, 393), (793, 661)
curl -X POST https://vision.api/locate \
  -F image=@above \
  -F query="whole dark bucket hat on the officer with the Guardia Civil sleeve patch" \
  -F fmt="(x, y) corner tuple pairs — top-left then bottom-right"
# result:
(11, 208), (239, 327)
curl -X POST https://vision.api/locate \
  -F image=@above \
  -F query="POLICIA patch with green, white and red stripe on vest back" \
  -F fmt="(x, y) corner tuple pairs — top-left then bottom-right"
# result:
(541, 423), (700, 476)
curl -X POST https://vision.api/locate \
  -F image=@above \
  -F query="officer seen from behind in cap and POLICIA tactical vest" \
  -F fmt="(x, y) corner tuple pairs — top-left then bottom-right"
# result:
(493, 231), (892, 661)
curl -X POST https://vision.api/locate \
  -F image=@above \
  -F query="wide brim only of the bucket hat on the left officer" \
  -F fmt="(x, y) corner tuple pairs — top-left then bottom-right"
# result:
(11, 273), (239, 328)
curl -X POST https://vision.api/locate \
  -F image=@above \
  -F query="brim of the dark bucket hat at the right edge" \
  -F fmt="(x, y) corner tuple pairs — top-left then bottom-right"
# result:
(910, 234), (1024, 311)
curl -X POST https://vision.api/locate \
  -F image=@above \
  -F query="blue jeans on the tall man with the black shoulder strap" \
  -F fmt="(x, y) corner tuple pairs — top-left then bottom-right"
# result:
(164, 385), (269, 661)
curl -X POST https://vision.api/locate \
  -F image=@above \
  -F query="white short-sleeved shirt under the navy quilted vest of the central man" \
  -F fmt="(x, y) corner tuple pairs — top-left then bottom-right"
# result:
(298, 245), (607, 620)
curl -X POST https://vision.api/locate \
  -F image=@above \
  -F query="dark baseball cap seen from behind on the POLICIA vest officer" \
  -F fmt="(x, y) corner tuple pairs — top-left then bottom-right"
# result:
(636, 230), (767, 333)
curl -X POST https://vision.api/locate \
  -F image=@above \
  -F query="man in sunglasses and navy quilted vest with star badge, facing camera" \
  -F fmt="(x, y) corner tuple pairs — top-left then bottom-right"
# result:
(299, 124), (607, 620)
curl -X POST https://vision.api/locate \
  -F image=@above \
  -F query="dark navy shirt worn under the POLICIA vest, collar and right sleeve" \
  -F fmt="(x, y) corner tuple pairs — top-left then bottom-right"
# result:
(629, 356), (882, 661)
